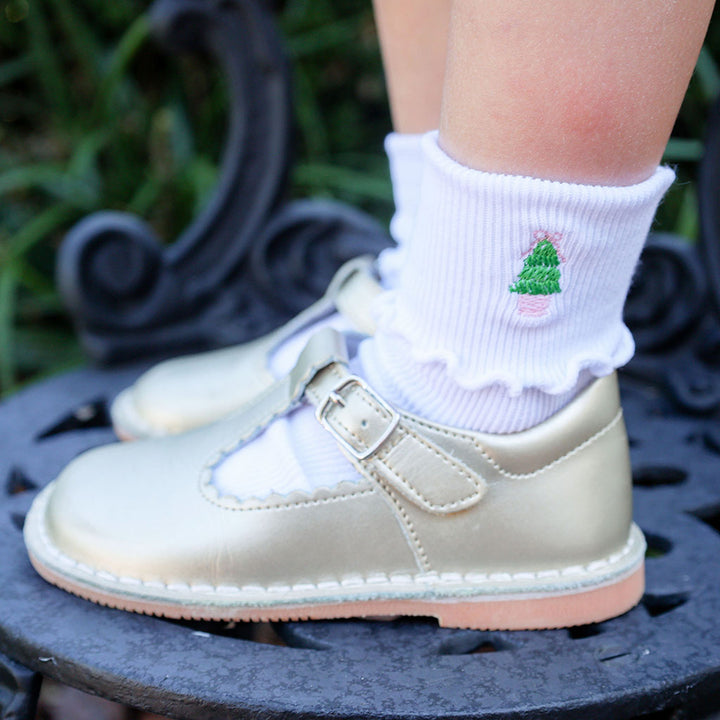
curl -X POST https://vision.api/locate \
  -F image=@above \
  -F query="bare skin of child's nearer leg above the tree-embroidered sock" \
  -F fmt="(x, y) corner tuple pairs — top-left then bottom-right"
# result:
(440, 0), (714, 185)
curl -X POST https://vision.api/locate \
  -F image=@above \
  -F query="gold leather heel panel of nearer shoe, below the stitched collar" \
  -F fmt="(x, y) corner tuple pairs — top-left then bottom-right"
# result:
(402, 411), (632, 573)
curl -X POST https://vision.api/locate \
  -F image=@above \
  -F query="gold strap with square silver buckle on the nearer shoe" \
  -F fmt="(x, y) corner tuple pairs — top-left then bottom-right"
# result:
(305, 344), (487, 514)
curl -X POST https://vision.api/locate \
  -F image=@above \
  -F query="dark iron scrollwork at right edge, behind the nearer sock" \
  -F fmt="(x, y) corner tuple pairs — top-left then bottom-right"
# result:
(623, 92), (720, 414)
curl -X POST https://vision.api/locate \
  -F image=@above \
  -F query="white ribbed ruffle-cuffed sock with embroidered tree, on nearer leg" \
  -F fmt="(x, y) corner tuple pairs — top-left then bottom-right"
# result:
(360, 133), (674, 433)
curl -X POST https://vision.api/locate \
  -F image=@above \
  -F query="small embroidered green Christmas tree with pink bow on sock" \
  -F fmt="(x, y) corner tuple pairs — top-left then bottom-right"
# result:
(509, 231), (564, 317)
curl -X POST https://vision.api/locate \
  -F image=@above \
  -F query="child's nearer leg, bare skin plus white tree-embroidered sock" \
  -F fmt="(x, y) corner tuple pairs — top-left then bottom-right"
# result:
(363, 0), (713, 432)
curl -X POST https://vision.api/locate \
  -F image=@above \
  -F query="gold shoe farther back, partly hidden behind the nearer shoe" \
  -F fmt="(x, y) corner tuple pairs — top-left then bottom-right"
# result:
(110, 257), (381, 440)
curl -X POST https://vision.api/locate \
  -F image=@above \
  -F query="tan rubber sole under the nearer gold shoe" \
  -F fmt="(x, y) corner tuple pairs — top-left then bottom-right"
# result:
(30, 553), (645, 630)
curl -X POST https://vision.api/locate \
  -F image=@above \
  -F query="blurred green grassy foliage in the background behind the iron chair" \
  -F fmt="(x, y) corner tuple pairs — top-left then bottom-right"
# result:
(0, 0), (720, 393)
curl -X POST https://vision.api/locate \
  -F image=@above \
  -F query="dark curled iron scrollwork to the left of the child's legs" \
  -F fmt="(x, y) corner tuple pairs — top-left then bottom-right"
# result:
(58, 0), (389, 361)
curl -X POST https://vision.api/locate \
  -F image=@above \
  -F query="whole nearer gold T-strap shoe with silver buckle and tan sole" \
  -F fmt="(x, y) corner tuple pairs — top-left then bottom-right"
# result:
(25, 329), (645, 629)
